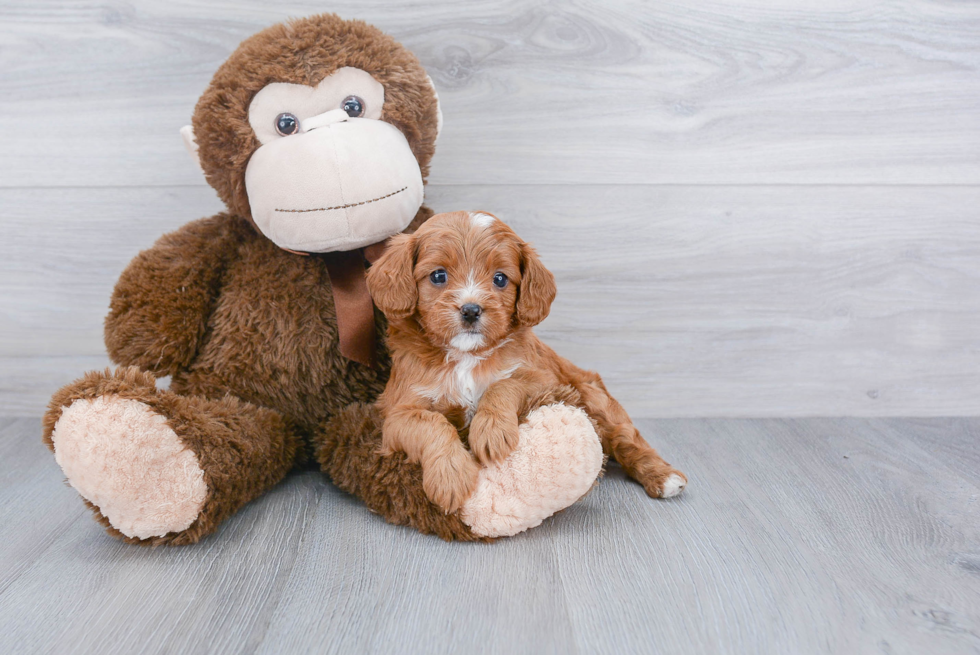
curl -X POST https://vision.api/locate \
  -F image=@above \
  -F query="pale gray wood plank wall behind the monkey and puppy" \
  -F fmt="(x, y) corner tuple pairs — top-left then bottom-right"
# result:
(0, 0), (980, 416)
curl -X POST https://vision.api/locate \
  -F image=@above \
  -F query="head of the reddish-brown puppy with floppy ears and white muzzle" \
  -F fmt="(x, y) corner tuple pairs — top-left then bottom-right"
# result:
(368, 212), (555, 353)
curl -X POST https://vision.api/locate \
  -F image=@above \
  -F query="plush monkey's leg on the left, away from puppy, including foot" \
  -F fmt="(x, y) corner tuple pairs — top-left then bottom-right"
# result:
(43, 367), (303, 545)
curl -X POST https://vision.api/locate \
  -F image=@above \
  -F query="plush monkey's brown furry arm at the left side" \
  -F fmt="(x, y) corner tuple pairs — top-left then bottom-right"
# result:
(105, 214), (248, 376)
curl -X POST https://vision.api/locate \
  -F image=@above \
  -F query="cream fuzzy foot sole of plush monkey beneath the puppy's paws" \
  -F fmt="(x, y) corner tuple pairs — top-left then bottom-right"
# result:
(460, 403), (603, 537)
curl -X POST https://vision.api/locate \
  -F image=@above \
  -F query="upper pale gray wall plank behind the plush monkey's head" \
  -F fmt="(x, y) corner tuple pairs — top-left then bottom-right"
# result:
(0, 0), (980, 187)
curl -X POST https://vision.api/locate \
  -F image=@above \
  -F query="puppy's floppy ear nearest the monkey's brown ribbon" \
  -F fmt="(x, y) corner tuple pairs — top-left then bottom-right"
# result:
(367, 234), (419, 318)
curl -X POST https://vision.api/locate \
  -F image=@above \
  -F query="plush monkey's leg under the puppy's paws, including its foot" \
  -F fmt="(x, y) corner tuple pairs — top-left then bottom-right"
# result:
(314, 403), (603, 541)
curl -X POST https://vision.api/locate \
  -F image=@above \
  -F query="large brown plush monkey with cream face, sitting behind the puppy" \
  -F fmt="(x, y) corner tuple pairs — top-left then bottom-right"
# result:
(43, 15), (602, 544)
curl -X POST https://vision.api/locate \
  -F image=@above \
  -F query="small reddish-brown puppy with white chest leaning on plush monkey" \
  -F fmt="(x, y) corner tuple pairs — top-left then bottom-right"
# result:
(367, 212), (687, 512)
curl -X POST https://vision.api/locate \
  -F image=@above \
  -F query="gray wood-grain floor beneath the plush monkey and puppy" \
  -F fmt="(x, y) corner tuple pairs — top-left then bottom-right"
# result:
(0, 419), (980, 655)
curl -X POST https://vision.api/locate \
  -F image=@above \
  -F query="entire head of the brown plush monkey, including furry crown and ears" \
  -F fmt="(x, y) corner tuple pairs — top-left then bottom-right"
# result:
(188, 14), (441, 252)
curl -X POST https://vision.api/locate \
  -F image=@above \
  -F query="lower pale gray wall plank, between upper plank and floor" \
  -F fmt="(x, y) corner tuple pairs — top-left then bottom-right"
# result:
(0, 185), (980, 416)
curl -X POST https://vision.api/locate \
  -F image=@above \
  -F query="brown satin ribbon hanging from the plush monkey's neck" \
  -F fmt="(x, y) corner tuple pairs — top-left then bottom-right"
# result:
(322, 240), (387, 366)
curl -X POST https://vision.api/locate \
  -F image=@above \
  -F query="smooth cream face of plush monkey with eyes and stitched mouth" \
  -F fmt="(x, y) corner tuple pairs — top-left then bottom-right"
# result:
(245, 67), (423, 252)
